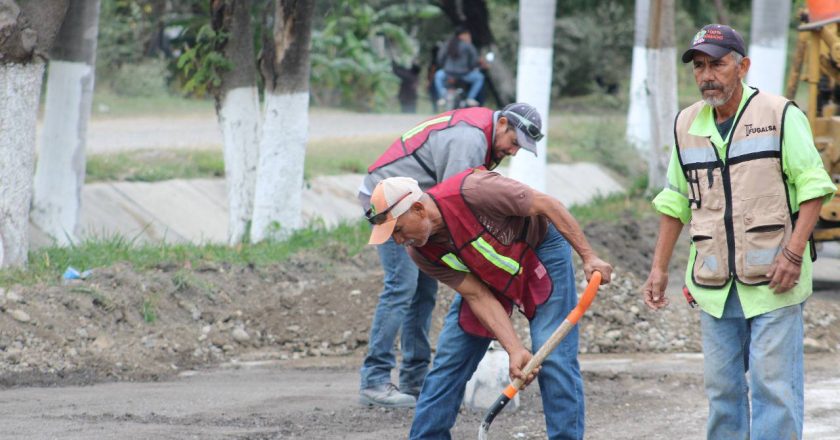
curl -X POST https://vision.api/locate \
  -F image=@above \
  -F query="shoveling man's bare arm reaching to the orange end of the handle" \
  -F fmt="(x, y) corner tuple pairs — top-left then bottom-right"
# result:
(528, 191), (612, 284)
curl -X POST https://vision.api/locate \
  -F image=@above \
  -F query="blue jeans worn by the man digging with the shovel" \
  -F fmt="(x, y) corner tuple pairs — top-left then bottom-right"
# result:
(410, 226), (584, 440)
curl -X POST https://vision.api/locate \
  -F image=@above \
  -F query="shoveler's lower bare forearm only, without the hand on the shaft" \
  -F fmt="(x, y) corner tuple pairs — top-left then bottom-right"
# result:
(455, 274), (522, 353)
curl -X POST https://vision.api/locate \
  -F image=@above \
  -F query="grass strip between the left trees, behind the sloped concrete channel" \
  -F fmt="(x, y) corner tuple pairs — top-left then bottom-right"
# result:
(85, 150), (225, 183)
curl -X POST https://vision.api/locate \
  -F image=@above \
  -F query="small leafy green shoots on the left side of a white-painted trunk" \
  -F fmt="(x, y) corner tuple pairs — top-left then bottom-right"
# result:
(178, 24), (234, 96)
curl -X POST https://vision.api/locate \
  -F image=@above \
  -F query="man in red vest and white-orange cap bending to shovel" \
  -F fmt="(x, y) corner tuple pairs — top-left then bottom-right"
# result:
(366, 169), (612, 439)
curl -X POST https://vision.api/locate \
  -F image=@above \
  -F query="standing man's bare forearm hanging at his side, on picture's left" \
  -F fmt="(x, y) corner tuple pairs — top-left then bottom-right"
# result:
(642, 215), (683, 310)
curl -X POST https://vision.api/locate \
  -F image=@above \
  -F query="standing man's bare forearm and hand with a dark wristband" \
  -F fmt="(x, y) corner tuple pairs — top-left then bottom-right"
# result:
(767, 198), (822, 293)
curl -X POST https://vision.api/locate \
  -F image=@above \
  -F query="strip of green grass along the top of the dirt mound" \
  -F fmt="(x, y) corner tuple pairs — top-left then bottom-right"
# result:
(0, 221), (370, 290)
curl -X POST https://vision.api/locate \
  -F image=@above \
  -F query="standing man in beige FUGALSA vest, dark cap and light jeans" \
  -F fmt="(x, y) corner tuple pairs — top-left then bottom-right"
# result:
(643, 25), (835, 439)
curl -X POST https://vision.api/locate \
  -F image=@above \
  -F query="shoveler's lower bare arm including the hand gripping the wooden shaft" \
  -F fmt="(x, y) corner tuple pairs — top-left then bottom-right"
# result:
(456, 273), (538, 384)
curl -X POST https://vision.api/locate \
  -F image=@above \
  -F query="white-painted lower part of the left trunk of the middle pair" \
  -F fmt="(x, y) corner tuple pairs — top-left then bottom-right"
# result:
(219, 87), (261, 245)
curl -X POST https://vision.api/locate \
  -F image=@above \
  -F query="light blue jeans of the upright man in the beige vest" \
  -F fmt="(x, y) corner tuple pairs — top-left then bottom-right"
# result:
(700, 284), (805, 440)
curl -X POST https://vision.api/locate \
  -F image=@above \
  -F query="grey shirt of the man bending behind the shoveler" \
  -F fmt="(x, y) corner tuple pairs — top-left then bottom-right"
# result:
(359, 112), (499, 209)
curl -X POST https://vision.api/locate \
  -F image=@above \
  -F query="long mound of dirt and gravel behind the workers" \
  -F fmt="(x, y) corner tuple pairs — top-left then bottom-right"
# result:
(0, 223), (840, 386)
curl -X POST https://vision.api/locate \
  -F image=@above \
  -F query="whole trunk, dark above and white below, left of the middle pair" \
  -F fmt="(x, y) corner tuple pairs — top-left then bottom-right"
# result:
(212, 0), (261, 244)
